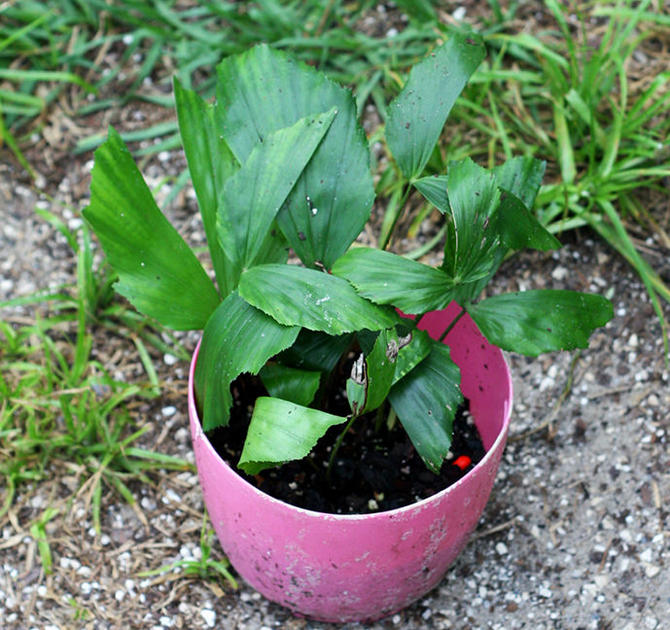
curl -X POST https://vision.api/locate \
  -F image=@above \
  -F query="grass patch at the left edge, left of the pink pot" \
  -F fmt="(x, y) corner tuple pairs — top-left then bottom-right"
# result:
(0, 217), (190, 528)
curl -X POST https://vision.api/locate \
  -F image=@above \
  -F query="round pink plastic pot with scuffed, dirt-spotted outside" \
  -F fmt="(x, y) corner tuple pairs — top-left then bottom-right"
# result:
(188, 304), (512, 622)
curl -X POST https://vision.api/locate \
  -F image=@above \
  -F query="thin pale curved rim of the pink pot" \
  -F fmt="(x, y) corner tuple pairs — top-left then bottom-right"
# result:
(188, 326), (513, 521)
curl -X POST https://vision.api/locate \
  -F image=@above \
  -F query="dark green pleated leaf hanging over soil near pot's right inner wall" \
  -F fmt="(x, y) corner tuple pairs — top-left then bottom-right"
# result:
(389, 342), (463, 473)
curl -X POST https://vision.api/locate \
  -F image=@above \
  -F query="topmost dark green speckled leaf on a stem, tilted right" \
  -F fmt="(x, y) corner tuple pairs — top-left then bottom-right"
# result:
(386, 33), (485, 180)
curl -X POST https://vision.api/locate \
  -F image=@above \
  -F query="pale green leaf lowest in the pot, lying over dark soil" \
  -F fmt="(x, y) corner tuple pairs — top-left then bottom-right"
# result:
(238, 396), (347, 475)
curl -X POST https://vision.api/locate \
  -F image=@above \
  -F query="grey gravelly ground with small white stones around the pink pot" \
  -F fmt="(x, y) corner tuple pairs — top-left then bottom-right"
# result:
(0, 138), (670, 630)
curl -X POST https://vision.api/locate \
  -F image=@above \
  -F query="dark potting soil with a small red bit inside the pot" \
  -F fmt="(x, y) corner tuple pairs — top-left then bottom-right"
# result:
(208, 376), (486, 514)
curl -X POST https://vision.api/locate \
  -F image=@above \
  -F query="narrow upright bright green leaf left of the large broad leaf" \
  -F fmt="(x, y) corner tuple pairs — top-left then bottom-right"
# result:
(174, 78), (239, 297)
